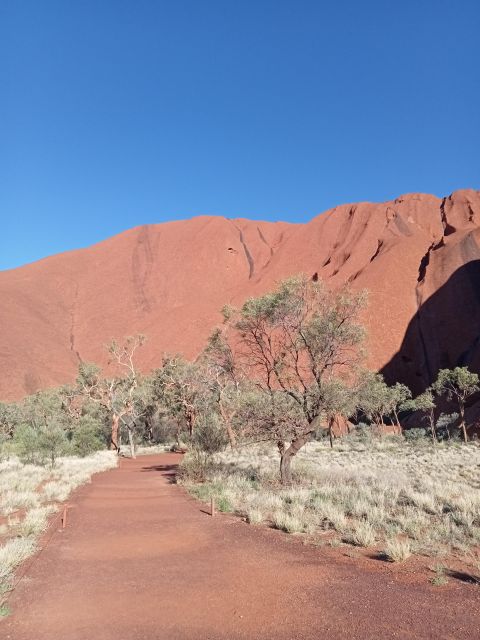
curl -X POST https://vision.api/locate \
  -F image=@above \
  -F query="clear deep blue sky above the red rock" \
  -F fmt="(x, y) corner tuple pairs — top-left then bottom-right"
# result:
(0, 0), (480, 269)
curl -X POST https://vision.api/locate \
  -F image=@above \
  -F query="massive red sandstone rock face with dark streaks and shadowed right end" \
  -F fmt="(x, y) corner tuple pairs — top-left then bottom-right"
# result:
(0, 190), (480, 400)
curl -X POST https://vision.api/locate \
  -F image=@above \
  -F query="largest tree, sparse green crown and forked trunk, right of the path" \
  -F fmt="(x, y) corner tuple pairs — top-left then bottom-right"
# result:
(216, 276), (366, 483)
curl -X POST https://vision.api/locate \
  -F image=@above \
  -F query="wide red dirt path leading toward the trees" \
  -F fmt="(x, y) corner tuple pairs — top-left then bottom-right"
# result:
(0, 454), (480, 640)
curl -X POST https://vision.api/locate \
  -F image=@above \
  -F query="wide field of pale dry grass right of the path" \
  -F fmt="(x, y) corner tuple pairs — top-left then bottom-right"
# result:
(180, 436), (480, 562)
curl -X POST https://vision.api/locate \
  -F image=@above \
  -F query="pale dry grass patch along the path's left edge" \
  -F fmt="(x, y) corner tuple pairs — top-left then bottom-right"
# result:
(0, 451), (117, 608)
